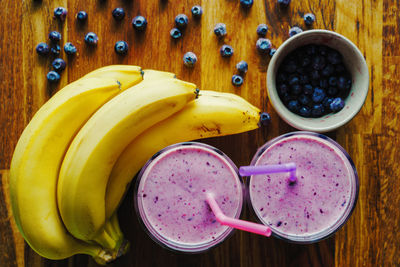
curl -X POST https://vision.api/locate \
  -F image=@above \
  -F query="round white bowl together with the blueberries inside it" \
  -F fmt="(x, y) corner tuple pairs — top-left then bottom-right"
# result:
(267, 30), (369, 132)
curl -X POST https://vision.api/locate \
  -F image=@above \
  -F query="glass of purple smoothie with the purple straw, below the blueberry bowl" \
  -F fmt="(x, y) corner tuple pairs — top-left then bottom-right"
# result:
(247, 132), (359, 243)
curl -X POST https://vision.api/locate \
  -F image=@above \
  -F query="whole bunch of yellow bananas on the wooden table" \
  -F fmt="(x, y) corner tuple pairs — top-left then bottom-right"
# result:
(10, 65), (260, 264)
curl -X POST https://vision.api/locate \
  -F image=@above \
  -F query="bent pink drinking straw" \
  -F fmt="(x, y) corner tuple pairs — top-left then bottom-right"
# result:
(206, 193), (271, 239)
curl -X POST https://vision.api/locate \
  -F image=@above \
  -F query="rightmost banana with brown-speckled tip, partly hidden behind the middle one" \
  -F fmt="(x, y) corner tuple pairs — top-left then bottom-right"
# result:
(106, 90), (260, 218)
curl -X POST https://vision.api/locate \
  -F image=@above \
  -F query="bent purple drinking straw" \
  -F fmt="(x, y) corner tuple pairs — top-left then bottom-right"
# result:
(239, 162), (297, 182)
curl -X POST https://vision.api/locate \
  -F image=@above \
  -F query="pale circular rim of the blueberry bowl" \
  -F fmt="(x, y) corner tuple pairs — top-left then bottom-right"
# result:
(266, 29), (370, 133)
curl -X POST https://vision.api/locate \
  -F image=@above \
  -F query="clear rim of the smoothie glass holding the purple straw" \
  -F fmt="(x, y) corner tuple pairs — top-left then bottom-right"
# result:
(246, 131), (359, 244)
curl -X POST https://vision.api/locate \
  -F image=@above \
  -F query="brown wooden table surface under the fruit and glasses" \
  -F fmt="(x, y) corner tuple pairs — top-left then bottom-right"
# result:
(0, 0), (400, 267)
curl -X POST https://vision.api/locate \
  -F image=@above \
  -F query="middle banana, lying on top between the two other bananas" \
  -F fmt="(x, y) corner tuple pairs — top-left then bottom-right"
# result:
(57, 79), (196, 241)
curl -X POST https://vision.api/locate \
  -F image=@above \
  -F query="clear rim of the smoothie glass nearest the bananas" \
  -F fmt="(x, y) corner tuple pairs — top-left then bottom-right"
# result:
(134, 142), (245, 254)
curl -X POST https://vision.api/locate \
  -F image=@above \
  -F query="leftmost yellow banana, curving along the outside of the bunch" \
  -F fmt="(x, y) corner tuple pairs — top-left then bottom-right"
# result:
(10, 67), (142, 263)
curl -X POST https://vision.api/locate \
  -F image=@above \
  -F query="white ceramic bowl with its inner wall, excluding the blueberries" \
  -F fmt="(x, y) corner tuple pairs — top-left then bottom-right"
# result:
(267, 30), (369, 132)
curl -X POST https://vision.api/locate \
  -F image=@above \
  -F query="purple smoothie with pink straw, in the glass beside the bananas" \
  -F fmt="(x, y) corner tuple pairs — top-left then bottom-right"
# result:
(135, 143), (243, 252)
